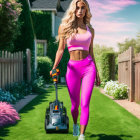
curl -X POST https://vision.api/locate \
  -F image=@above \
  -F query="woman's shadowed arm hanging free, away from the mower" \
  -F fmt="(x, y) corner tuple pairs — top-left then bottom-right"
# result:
(89, 28), (98, 72)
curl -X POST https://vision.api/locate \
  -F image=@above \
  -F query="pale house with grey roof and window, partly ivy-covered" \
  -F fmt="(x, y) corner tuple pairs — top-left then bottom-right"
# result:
(28, 0), (71, 71)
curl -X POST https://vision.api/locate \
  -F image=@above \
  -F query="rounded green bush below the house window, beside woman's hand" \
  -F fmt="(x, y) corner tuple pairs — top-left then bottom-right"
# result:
(37, 56), (53, 83)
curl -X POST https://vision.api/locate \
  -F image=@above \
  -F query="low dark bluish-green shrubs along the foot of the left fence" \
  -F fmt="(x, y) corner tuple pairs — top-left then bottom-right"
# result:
(0, 76), (44, 104)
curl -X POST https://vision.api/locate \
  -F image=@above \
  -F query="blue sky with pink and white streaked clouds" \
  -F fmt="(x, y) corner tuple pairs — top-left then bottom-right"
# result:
(87, 0), (140, 51)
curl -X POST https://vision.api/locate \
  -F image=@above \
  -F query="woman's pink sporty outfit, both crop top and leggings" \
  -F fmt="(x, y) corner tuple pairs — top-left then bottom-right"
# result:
(65, 25), (96, 125)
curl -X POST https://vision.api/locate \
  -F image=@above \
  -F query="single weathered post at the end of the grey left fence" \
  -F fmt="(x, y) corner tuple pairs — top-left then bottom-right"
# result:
(26, 49), (31, 82)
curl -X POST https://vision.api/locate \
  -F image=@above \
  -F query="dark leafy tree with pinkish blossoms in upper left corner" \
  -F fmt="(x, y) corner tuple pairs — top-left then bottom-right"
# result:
(0, 0), (22, 50)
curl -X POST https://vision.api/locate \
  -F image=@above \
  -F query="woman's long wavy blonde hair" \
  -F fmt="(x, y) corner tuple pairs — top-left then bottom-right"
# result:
(56, 0), (92, 42)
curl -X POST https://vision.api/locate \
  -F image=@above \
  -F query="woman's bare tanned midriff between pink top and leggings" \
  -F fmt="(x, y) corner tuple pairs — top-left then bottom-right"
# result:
(69, 50), (89, 60)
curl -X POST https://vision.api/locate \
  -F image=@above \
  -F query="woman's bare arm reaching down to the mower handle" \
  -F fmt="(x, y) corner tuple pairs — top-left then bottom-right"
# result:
(52, 25), (65, 69)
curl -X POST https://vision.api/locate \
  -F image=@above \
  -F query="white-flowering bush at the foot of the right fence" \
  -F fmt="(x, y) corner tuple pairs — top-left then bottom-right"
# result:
(104, 80), (128, 99)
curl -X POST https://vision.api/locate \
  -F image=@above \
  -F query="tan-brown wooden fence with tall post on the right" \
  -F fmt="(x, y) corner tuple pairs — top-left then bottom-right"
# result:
(118, 47), (140, 102)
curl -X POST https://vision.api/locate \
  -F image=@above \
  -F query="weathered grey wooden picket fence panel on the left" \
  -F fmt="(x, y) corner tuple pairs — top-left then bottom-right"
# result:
(0, 51), (23, 89)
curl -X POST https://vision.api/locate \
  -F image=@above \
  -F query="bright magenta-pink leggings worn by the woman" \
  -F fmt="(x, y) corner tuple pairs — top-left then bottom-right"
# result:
(65, 54), (96, 125)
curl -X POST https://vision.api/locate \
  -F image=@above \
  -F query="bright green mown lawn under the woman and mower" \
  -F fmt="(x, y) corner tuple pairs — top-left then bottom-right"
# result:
(0, 85), (140, 140)
